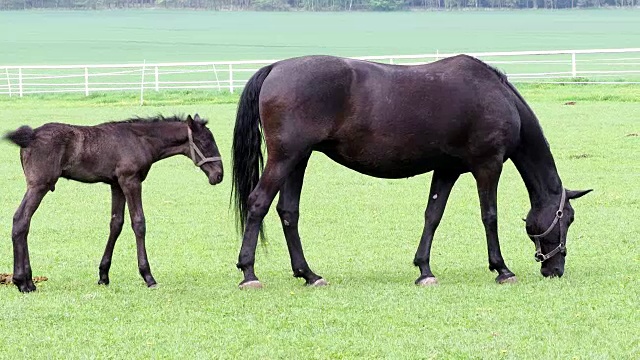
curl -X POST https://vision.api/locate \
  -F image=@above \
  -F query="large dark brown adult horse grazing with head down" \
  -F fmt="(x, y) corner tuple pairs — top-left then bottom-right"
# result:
(233, 55), (590, 288)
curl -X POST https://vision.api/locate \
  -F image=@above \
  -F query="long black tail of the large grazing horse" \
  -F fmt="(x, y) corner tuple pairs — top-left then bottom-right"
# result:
(231, 65), (271, 239)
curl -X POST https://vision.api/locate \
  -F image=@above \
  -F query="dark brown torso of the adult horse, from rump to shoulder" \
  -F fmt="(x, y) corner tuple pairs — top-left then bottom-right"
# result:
(260, 55), (519, 177)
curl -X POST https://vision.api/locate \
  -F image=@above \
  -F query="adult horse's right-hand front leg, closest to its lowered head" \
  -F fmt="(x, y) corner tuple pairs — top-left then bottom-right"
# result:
(472, 157), (516, 284)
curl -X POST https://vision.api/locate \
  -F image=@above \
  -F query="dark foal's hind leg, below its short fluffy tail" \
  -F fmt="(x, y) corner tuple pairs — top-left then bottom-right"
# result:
(11, 186), (50, 292)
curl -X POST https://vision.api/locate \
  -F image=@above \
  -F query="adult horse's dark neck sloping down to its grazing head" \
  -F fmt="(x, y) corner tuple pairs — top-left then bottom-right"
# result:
(511, 117), (562, 208)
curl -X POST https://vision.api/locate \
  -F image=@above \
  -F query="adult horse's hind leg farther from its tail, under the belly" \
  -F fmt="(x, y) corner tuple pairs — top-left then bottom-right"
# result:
(276, 157), (327, 286)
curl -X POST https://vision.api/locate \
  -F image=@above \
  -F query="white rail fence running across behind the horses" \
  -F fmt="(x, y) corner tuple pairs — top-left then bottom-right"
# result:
(0, 48), (640, 97)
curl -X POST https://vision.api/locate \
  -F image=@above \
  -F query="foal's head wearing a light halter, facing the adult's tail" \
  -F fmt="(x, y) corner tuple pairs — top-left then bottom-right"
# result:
(187, 114), (224, 185)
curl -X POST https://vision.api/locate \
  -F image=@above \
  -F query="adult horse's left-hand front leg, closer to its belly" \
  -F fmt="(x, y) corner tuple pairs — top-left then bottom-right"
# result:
(413, 170), (460, 285)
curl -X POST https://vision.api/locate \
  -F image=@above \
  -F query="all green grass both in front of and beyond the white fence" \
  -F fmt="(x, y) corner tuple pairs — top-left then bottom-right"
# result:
(0, 10), (640, 359)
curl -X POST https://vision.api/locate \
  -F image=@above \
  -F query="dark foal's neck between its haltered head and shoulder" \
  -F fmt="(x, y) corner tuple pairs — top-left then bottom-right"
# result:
(134, 122), (187, 162)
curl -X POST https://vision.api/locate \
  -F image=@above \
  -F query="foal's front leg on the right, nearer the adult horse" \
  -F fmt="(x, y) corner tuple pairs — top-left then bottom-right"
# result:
(118, 177), (157, 287)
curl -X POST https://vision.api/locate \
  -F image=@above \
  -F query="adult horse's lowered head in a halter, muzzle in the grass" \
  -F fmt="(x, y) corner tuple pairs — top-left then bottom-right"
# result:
(525, 189), (591, 277)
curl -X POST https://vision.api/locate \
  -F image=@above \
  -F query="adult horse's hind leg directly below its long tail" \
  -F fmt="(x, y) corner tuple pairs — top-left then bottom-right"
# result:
(236, 156), (297, 288)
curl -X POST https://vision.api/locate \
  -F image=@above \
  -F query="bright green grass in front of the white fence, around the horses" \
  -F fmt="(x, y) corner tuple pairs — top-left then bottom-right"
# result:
(0, 86), (640, 359)
